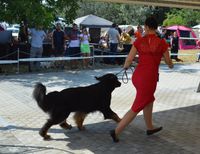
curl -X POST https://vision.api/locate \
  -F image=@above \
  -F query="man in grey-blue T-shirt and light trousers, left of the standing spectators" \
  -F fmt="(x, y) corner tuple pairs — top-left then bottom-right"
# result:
(29, 25), (46, 72)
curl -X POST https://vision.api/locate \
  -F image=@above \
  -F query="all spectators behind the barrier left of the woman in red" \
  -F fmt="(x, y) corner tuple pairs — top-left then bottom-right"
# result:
(24, 23), (143, 71)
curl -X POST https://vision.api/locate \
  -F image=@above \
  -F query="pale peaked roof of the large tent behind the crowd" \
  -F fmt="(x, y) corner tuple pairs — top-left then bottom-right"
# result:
(74, 14), (112, 28)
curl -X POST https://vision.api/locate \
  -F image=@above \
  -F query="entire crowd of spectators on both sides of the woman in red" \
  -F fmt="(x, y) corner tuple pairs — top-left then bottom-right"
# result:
(0, 19), (186, 71)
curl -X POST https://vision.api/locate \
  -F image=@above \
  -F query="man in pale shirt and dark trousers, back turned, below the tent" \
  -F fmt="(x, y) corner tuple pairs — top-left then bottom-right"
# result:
(107, 23), (120, 64)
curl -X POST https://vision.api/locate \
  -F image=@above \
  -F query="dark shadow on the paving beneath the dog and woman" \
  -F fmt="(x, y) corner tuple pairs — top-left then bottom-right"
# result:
(0, 105), (200, 154)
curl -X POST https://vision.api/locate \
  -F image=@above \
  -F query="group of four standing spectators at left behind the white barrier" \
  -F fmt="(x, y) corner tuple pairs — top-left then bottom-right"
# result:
(26, 23), (91, 71)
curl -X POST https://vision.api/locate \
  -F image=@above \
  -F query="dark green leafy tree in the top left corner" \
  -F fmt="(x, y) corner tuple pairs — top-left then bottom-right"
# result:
(0, 0), (81, 26)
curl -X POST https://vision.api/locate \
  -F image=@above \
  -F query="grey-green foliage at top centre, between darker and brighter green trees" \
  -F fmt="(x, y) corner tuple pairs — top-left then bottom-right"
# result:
(77, 0), (166, 25)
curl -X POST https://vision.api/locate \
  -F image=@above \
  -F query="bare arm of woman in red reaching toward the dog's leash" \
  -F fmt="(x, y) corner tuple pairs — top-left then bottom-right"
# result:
(124, 45), (137, 69)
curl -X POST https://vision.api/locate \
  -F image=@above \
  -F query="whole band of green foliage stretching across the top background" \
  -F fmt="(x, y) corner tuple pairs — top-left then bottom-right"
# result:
(0, 0), (200, 27)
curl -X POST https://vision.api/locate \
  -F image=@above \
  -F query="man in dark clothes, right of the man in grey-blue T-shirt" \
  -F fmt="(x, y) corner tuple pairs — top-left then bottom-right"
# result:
(52, 23), (65, 57)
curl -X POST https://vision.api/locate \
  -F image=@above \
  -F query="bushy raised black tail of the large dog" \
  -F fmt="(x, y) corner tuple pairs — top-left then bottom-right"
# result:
(33, 83), (48, 112)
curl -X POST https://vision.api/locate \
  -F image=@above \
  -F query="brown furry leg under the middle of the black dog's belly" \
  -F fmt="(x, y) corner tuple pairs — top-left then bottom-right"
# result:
(74, 112), (87, 130)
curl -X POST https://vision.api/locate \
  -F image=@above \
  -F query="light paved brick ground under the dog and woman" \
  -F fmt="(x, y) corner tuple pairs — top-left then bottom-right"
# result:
(0, 64), (200, 154)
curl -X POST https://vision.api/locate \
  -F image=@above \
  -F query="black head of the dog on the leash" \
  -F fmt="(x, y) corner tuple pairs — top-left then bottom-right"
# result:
(95, 73), (121, 89)
